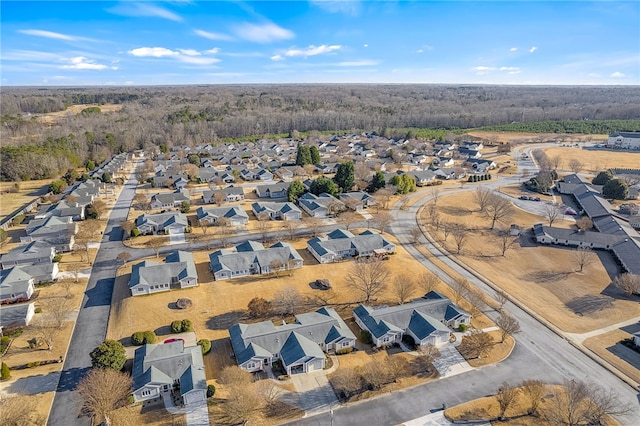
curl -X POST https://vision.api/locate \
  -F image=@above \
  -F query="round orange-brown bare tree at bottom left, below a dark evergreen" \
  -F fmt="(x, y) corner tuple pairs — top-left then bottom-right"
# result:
(77, 368), (133, 425)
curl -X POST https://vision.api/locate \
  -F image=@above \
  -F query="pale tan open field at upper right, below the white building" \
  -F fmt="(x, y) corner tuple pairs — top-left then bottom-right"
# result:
(544, 146), (640, 174)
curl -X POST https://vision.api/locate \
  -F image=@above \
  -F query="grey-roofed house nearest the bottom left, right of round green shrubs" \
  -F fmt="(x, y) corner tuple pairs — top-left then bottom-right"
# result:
(131, 340), (207, 408)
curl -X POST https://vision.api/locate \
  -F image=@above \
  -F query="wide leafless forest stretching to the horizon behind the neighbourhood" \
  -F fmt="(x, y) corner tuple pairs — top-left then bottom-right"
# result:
(0, 85), (640, 180)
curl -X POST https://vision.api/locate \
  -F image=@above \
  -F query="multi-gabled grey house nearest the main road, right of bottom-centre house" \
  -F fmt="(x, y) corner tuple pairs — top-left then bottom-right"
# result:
(353, 291), (471, 347)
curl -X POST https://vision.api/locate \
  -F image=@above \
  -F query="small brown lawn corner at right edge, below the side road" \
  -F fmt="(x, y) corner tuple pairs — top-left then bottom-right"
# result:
(583, 329), (640, 382)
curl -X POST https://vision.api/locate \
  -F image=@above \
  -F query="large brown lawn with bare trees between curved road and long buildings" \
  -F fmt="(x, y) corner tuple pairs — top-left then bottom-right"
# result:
(421, 193), (640, 333)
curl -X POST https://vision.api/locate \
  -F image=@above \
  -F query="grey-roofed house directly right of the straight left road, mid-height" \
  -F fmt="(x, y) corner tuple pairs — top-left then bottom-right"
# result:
(129, 250), (198, 296)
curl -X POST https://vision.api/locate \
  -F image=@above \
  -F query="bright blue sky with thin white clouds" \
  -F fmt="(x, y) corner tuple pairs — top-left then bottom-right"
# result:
(0, 0), (640, 86)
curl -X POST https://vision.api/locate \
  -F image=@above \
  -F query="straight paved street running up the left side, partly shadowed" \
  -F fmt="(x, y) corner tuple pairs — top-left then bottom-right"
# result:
(48, 161), (136, 426)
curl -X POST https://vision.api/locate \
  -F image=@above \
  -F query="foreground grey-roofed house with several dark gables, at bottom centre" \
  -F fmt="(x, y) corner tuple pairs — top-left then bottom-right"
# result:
(229, 308), (356, 375)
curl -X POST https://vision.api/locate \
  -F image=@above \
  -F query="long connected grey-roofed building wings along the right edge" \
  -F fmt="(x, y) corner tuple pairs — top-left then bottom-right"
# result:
(533, 174), (640, 275)
